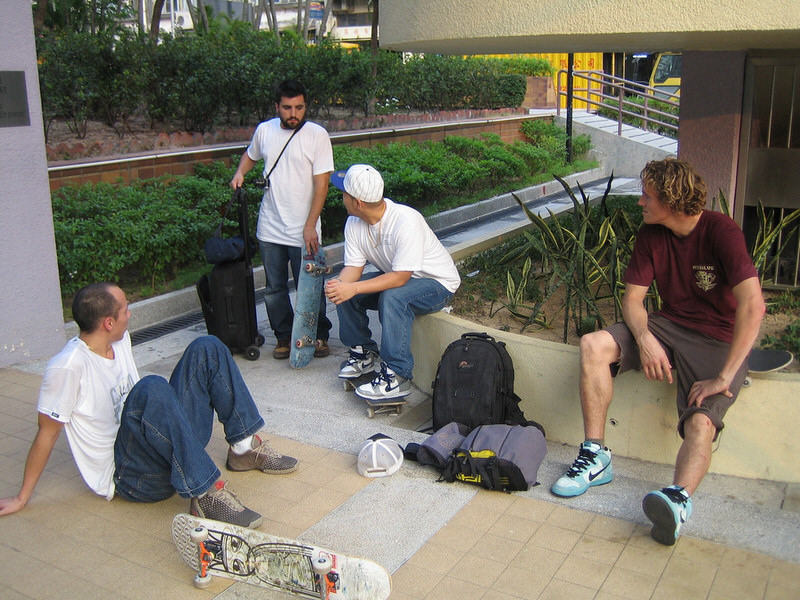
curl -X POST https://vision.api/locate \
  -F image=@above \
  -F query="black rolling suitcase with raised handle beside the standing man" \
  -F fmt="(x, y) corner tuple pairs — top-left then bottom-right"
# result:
(197, 188), (264, 360)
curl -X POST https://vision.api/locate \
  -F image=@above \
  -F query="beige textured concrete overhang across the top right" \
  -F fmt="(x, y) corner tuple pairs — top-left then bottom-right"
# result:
(380, 0), (800, 54)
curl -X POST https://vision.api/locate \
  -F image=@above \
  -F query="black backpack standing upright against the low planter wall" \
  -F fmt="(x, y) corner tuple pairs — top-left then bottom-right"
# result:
(433, 333), (544, 433)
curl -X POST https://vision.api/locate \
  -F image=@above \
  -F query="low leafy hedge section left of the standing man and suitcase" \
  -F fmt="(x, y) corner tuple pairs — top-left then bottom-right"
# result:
(53, 178), (228, 295)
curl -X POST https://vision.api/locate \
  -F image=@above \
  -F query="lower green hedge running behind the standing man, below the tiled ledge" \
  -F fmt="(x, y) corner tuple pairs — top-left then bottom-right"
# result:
(52, 126), (588, 297)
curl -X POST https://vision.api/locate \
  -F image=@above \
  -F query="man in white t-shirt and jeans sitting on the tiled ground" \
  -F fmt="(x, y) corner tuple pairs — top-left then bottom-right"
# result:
(0, 283), (297, 527)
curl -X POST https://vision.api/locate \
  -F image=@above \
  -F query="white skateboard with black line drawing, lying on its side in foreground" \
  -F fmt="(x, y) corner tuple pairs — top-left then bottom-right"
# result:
(172, 514), (392, 600)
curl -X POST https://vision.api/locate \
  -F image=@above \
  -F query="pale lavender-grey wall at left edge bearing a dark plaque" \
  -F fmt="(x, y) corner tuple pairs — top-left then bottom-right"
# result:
(0, 0), (64, 367)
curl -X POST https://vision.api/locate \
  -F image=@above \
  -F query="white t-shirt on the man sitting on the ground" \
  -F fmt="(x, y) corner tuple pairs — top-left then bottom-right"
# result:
(38, 331), (139, 500)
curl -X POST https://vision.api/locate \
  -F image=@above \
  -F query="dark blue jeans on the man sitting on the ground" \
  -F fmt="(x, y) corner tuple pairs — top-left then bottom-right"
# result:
(114, 336), (264, 502)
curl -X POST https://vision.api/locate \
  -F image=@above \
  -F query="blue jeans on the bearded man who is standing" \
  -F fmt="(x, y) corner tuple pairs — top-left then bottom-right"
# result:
(258, 241), (333, 340)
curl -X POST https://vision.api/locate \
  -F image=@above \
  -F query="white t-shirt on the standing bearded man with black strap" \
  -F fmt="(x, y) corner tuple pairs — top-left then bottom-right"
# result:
(247, 118), (333, 247)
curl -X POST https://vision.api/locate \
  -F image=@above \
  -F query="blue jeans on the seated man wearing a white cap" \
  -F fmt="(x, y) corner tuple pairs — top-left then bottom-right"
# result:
(336, 273), (453, 379)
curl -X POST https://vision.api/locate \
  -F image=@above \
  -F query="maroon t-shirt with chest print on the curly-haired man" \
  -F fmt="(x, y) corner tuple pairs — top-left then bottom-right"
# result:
(625, 210), (758, 343)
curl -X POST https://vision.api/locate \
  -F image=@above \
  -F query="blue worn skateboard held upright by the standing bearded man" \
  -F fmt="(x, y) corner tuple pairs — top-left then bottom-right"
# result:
(289, 248), (332, 369)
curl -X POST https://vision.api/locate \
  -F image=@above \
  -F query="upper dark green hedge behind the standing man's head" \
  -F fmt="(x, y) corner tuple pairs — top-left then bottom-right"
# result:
(36, 22), (532, 135)
